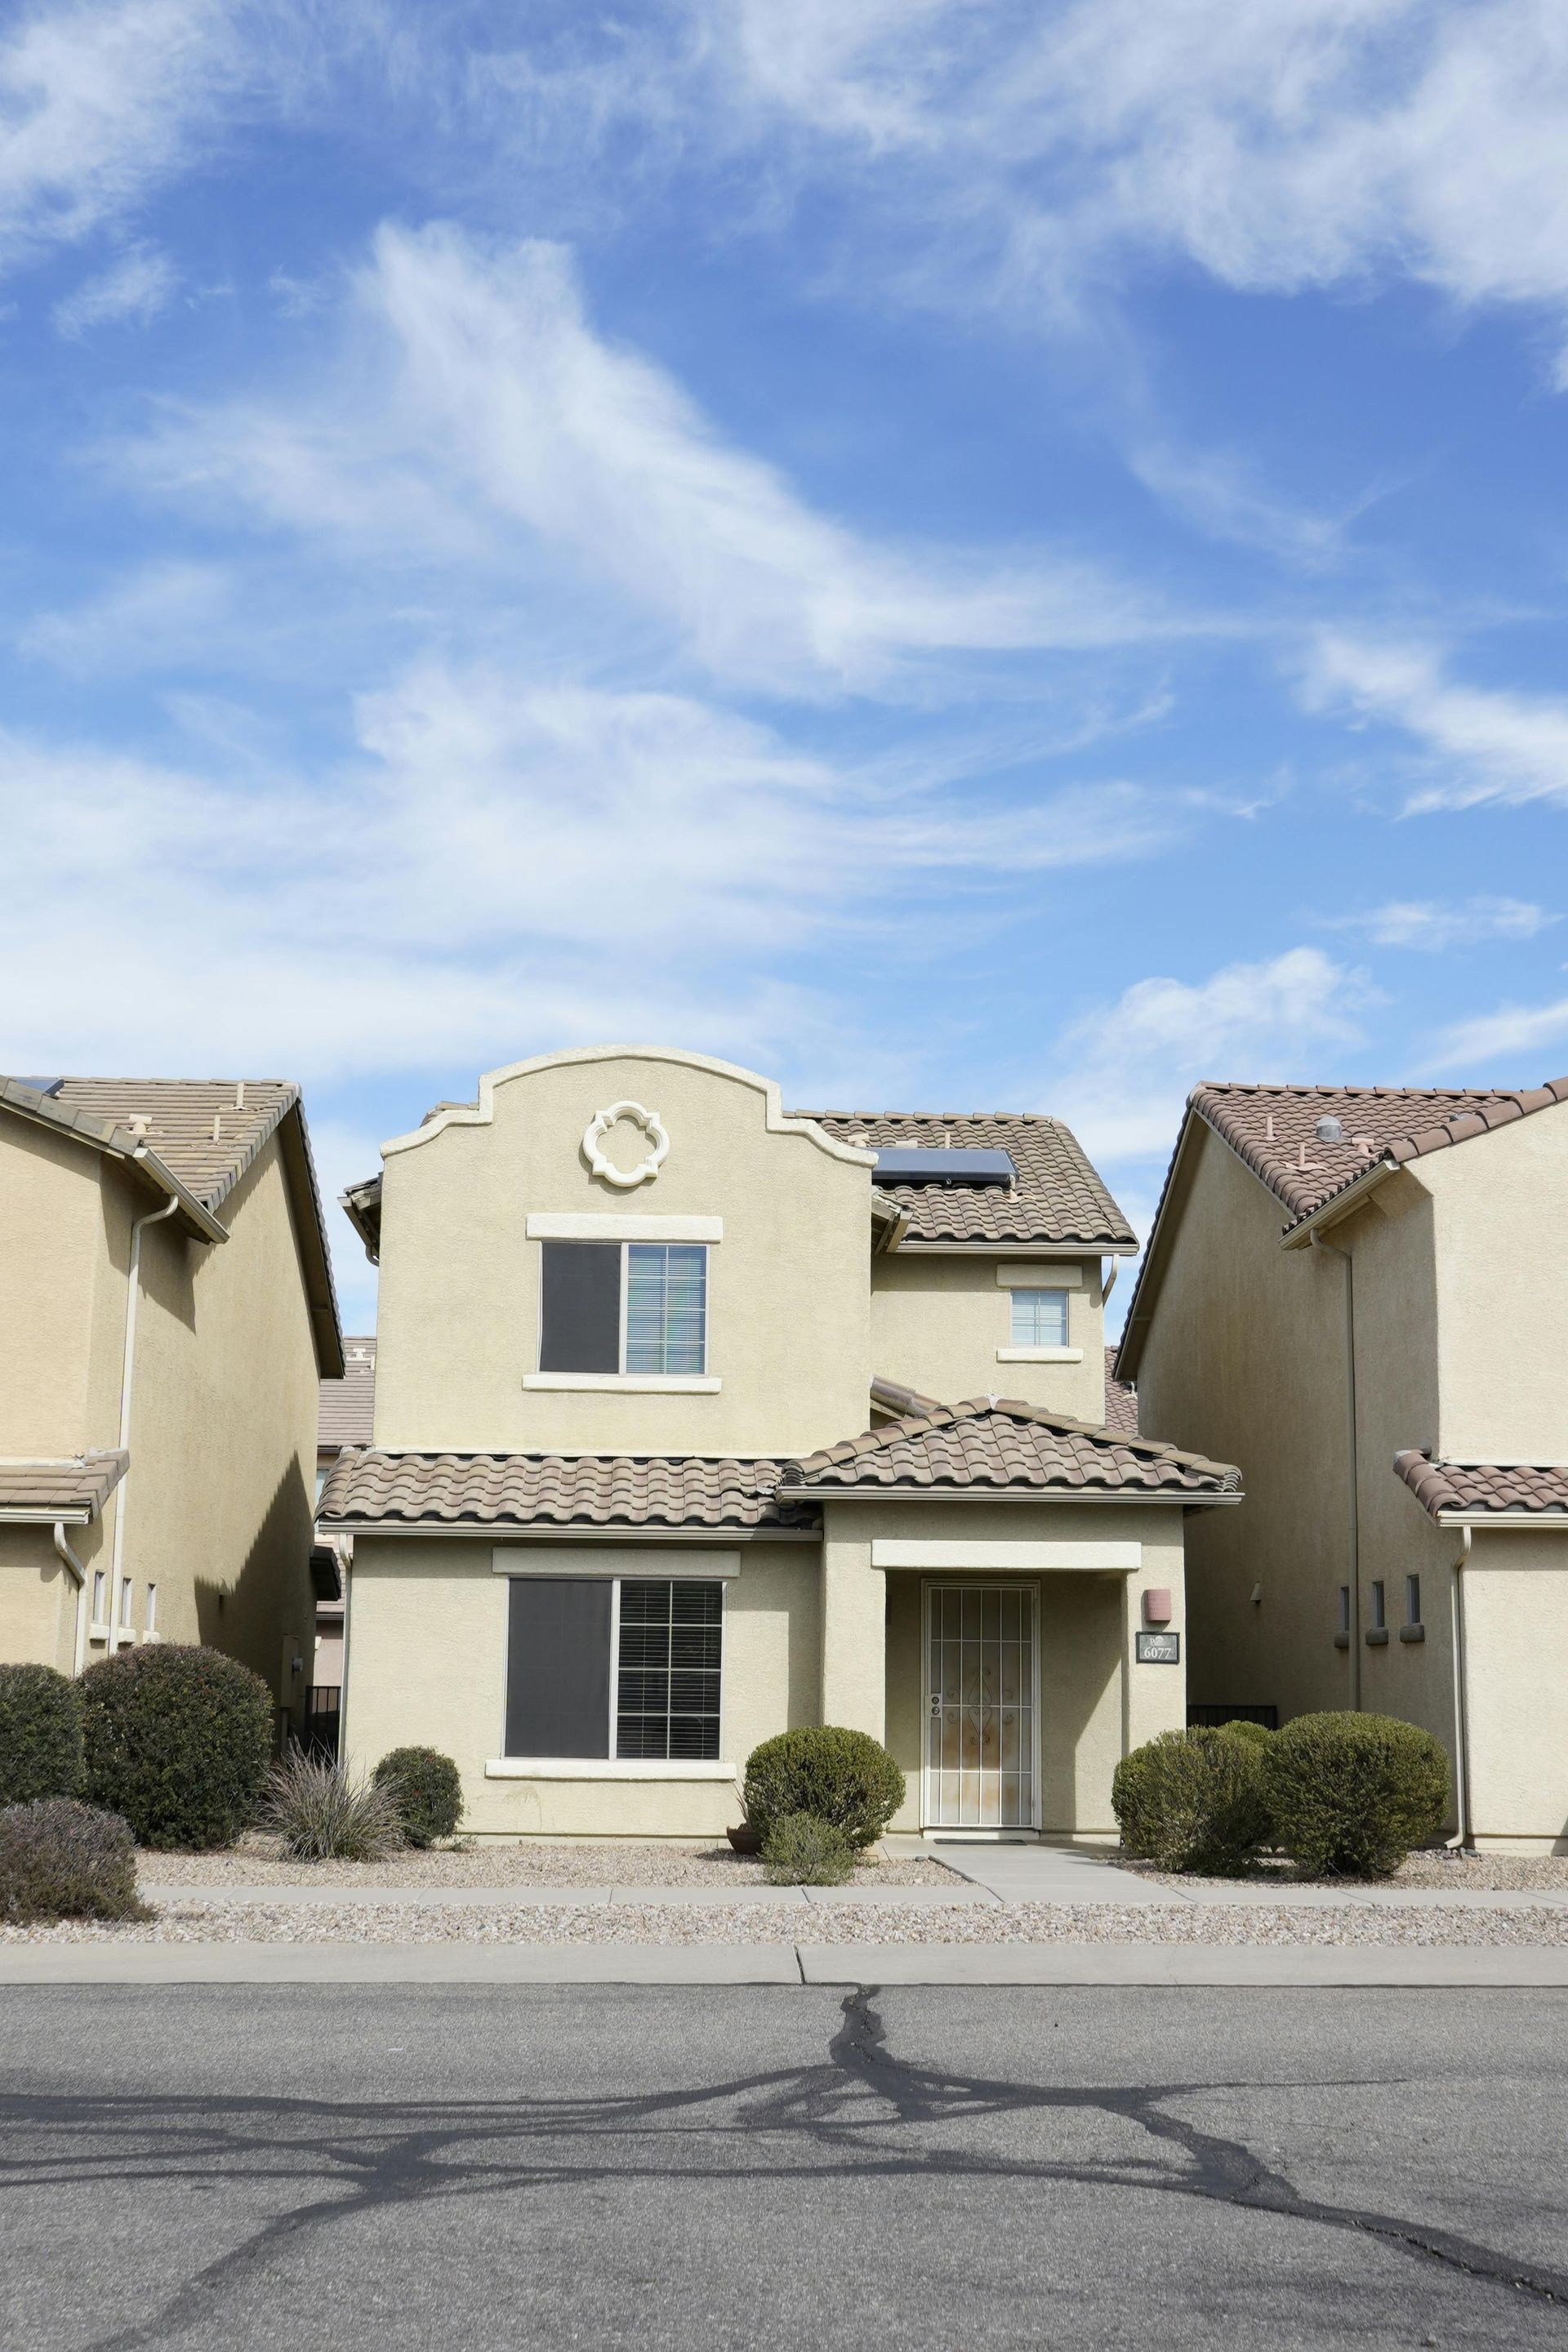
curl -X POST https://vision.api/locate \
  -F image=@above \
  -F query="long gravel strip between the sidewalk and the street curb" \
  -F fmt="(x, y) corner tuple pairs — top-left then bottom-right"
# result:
(12, 1895), (1568, 1950)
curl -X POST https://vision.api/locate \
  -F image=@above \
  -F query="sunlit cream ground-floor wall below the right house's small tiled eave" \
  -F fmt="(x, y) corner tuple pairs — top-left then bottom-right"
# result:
(1462, 1529), (1568, 1853)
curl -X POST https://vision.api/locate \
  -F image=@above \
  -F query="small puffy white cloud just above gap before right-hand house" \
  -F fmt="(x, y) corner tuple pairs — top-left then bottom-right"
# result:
(1051, 948), (1380, 1165)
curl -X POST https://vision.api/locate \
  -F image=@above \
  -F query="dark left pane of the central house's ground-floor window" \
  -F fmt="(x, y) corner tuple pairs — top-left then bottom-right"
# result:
(506, 1576), (616, 1757)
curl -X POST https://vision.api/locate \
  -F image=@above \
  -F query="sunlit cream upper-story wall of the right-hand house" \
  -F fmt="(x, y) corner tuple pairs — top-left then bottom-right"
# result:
(1413, 1103), (1568, 1463)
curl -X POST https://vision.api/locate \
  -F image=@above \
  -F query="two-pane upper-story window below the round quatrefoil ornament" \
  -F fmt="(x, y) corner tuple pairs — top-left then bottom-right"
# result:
(538, 1242), (707, 1379)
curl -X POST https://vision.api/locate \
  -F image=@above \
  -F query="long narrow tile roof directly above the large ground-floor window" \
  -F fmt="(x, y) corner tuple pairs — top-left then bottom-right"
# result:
(318, 1451), (813, 1531)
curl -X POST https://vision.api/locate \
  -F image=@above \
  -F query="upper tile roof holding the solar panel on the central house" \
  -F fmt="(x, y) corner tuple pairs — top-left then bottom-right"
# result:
(790, 1110), (1138, 1249)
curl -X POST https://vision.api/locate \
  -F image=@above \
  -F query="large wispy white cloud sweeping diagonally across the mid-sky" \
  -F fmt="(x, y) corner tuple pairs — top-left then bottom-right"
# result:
(118, 225), (1175, 694)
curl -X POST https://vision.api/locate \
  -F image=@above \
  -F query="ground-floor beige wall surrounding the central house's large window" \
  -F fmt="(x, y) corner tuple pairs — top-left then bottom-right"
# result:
(343, 1536), (821, 1839)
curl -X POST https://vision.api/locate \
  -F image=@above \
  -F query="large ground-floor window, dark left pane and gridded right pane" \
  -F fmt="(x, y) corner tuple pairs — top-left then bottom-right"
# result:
(506, 1576), (724, 1762)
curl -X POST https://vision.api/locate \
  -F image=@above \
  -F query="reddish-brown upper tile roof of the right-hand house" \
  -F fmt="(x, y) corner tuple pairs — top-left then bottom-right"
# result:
(1187, 1077), (1568, 1223)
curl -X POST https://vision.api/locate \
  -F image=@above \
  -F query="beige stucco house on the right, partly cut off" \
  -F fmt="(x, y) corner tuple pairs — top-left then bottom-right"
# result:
(1116, 1080), (1568, 1851)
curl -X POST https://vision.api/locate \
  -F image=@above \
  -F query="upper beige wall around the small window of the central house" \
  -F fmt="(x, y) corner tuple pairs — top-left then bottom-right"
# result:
(872, 1245), (1105, 1421)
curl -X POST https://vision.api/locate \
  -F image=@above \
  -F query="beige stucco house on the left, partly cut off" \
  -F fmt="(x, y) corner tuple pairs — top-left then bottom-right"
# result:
(0, 1077), (343, 1722)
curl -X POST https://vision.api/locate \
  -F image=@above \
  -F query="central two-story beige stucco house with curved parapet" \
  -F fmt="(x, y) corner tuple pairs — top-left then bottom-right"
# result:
(319, 1047), (1236, 1837)
